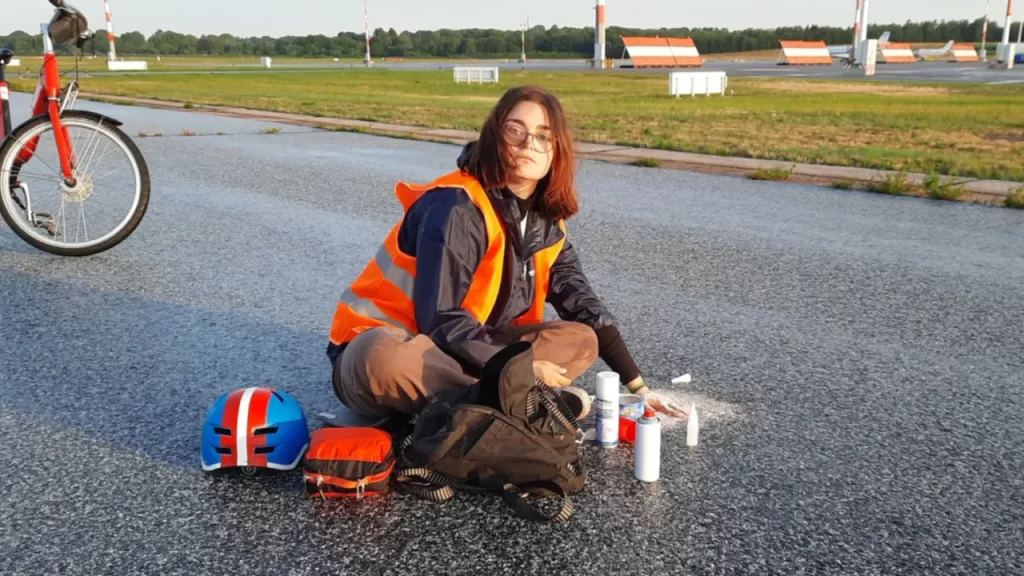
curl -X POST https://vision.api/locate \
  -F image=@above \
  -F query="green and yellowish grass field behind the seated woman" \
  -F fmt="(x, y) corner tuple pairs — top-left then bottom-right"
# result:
(9, 69), (1024, 181)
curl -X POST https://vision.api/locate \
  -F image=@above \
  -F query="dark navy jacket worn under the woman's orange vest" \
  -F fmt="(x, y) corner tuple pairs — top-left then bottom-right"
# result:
(328, 145), (616, 373)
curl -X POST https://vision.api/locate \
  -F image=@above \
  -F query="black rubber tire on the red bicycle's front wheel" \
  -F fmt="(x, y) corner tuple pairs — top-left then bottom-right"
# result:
(0, 111), (151, 256)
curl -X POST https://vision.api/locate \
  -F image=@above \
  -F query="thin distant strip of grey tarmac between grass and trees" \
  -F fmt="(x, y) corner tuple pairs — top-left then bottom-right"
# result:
(74, 60), (1024, 84)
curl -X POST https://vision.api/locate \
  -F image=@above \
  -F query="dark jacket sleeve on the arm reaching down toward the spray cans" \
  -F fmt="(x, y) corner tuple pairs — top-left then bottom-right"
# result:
(548, 240), (618, 330)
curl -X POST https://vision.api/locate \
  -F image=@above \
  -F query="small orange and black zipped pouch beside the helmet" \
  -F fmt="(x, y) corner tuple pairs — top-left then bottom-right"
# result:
(302, 427), (394, 498)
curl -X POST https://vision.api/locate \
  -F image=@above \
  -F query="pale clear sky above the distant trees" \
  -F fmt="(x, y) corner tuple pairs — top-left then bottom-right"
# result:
(0, 0), (1007, 37)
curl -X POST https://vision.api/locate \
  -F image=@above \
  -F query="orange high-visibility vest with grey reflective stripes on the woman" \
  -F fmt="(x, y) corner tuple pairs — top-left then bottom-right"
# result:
(331, 166), (566, 344)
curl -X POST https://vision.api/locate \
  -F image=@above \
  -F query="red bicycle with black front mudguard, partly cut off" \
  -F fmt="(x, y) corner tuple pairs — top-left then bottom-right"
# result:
(0, 0), (150, 256)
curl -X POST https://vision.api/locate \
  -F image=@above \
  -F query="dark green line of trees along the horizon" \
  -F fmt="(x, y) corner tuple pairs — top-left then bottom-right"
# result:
(0, 18), (1020, 58)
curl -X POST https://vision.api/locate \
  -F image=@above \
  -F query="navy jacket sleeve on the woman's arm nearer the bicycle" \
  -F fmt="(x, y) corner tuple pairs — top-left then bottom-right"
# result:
(414, 189), (502, 374)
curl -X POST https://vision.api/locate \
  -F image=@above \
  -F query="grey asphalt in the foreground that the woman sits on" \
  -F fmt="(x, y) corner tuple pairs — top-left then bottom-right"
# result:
(6, 94), (1024, 575)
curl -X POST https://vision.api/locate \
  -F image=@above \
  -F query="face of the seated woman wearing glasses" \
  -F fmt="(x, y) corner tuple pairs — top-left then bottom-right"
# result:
(502, 101), (555, 182)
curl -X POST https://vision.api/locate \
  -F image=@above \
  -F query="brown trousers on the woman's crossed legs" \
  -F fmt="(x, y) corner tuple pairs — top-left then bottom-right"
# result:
(332, 321), (597, 418)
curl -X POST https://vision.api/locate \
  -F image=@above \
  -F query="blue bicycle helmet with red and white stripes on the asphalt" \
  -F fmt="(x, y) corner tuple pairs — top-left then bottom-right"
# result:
(202, 387), (309, 474)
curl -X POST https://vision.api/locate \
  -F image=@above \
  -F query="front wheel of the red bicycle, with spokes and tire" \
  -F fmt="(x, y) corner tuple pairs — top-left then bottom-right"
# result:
(0, 111), (150, 256)
